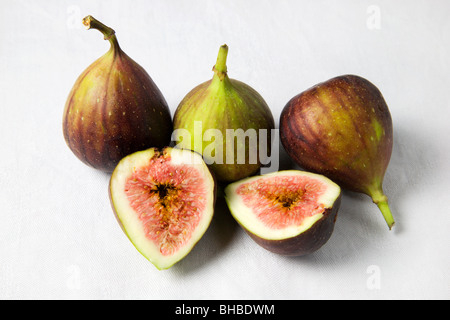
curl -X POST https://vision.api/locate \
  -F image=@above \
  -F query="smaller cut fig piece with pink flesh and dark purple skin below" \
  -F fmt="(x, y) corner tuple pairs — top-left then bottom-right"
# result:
(225, 170), (341, 256)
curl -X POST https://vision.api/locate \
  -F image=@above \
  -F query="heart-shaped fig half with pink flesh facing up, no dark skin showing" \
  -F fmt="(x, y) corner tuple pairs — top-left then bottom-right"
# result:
(109, 147), (216, 270)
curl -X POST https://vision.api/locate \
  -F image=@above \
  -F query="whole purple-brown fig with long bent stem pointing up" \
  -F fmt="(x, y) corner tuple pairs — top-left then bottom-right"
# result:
(63, 16), (173, 172)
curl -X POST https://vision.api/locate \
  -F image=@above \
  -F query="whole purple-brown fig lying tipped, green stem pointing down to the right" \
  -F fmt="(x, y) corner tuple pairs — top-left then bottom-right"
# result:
(280, 75), (395, 229)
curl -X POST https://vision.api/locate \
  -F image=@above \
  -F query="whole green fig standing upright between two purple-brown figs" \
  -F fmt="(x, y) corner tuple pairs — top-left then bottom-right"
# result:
(172, 45), (275, 182)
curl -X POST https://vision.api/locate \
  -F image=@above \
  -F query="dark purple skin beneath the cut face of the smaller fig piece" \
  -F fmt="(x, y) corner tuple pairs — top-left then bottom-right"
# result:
(243, 193), (342, 256)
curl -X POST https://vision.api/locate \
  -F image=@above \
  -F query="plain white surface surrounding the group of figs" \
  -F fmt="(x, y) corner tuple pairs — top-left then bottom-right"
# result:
(0, 0), (450, 299)
